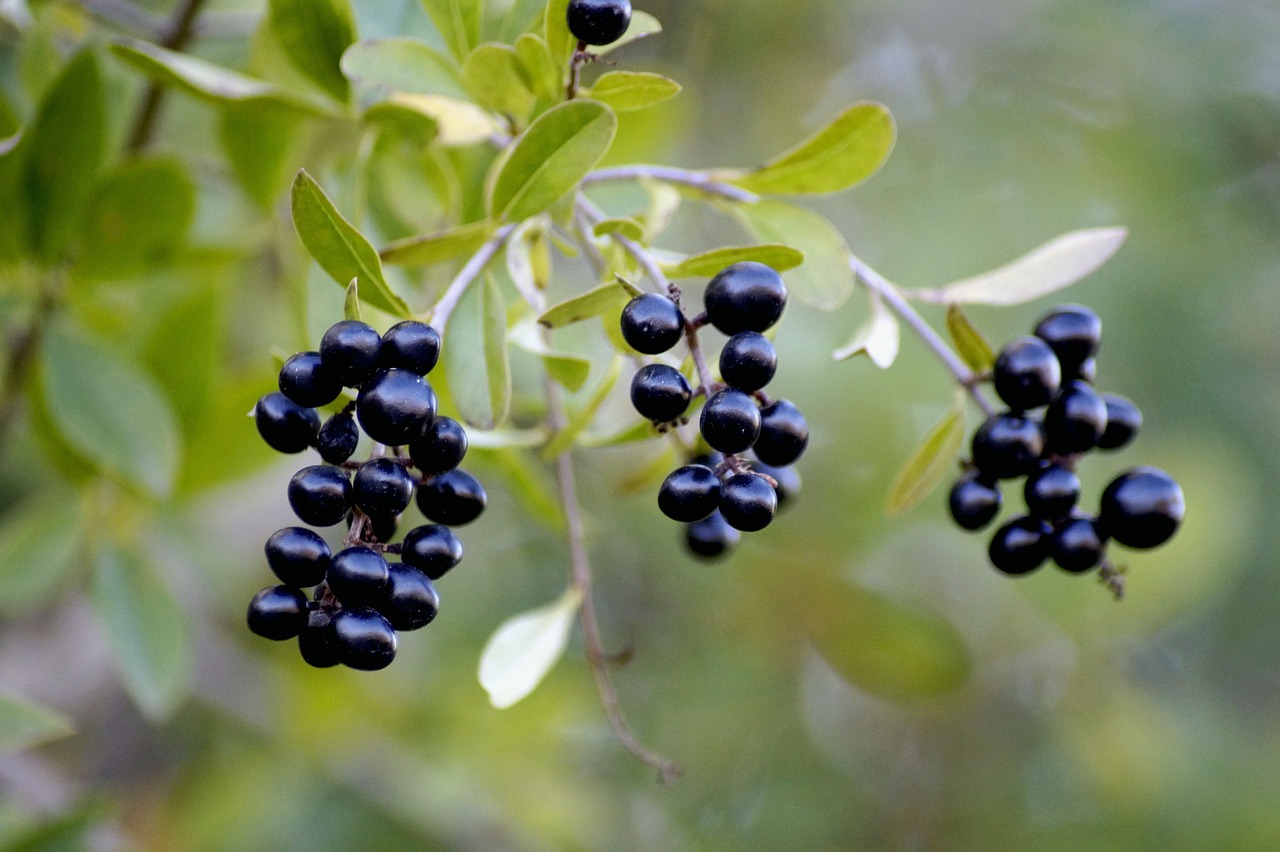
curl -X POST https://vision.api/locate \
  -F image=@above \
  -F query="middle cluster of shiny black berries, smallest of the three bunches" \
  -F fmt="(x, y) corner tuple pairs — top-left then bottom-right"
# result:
(622, 262), (809, 556)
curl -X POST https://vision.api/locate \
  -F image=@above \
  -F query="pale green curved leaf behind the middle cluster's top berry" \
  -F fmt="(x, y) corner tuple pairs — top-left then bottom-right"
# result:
(727, 201), (854, 311)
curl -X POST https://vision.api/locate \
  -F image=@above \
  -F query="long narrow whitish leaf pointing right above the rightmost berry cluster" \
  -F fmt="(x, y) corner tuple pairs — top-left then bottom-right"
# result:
(906, 228), (1129, 306)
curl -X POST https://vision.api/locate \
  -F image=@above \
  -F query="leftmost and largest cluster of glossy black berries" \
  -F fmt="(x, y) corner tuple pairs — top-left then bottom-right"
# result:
(248, 314), (486, 670)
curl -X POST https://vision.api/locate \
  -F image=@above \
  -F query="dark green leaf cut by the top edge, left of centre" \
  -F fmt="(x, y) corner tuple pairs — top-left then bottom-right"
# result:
(268, 0), (356, 101)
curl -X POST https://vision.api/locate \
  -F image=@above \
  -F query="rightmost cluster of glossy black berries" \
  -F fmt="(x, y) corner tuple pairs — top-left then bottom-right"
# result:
(951, 306), (1185, 574)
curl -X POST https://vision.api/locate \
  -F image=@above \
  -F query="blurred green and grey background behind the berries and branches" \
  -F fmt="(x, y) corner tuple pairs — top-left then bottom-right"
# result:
(0, 0), (1280, 849)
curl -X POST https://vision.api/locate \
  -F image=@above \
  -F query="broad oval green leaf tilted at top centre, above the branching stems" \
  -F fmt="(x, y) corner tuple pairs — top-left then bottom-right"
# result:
(488, 100), (618, 221)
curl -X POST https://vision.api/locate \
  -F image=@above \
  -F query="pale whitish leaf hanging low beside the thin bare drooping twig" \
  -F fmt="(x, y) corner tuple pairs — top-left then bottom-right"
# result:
(479, 586), (582, 710)
